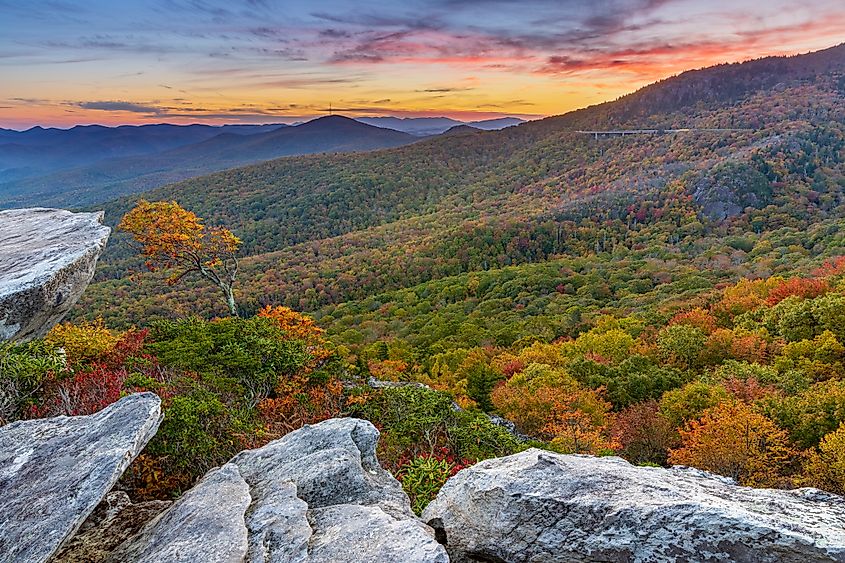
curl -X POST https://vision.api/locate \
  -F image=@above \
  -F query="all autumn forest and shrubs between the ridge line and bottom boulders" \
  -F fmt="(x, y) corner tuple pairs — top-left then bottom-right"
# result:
(0, 47), (845, 510)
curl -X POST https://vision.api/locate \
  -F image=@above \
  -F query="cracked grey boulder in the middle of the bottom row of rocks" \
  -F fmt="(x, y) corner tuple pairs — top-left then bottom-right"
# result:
(111, 418), (448, 563)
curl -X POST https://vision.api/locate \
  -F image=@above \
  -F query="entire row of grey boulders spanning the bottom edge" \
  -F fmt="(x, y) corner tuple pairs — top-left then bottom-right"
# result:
(0, 393), (845, 563)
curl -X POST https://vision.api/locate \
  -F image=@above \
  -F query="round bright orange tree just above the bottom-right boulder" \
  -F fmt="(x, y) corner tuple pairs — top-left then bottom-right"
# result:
(669, 401), (797, 486)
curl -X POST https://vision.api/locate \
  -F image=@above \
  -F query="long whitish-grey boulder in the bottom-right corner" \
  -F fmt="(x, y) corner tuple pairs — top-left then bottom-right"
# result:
(423, 449), (845, 563)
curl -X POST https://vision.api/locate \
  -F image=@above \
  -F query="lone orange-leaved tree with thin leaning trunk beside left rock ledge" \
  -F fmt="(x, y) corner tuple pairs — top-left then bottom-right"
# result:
(118, 200), (241, 316)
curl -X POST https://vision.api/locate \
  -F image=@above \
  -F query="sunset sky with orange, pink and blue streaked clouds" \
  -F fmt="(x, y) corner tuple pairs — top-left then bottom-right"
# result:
(0, 0), (845, 129)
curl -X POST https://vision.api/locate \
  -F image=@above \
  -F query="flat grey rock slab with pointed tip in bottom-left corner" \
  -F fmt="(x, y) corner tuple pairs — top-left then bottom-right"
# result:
(0, 393), (161, 563)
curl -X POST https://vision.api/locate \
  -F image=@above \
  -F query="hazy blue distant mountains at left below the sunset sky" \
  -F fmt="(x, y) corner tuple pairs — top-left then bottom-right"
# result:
(0, 116), (418, 208)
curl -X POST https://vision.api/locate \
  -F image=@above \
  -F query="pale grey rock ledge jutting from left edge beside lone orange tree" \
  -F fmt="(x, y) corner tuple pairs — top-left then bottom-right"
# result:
(0, 208), (111, 341)
